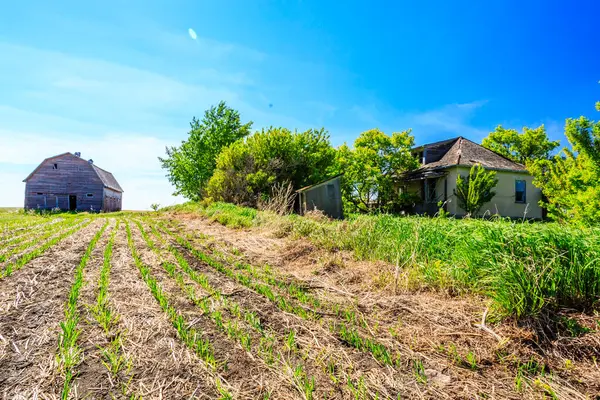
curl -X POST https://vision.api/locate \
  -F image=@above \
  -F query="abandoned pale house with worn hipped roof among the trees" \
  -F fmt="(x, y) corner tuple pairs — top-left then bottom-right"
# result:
(399, 137), (545, 219)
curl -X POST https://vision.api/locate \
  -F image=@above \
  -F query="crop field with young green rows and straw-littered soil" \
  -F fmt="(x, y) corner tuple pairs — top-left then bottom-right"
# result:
(0, 210), (600, 399)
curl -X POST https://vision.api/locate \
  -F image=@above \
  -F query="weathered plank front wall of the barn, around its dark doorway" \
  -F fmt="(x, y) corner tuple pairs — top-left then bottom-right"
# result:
(25, 154), (104, 211)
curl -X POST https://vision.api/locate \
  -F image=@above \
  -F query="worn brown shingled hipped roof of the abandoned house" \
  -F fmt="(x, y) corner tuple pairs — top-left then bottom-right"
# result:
(417, 136), (527, 172)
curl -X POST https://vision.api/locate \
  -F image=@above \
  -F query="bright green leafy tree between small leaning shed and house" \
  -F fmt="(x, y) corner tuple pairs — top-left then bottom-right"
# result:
(336, 129), (418, 212)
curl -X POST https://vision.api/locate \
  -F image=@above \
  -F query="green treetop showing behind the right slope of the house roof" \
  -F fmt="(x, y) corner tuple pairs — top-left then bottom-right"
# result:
(482, 125), (560, 165)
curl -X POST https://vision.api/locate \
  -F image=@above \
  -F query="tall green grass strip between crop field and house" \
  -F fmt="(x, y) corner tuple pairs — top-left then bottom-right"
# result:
(164, 203), (600, 318)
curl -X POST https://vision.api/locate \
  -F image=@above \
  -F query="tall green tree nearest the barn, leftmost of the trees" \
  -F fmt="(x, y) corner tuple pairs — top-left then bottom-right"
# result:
(159, 101), (252, 201)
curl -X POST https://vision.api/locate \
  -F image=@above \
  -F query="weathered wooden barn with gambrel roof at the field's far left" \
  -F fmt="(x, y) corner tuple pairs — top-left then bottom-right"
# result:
(23, 153), (123, 212)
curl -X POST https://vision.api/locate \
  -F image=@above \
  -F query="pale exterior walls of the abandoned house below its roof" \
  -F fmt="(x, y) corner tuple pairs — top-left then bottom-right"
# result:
(446, 167), (542, 219)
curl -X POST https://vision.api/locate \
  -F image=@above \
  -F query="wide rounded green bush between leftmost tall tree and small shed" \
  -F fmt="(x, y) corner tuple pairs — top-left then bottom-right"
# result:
(208, 127), (335, 206)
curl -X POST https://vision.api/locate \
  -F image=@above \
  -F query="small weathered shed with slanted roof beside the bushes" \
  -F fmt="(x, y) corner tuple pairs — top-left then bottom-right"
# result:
(296, 174), (344, 219)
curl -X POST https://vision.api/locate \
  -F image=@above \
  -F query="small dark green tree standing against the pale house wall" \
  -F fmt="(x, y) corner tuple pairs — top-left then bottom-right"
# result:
(454, 164), (498, 216)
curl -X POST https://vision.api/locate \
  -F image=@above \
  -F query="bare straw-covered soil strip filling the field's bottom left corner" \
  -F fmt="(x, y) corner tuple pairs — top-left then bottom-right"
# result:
(0, 221), (105, 398)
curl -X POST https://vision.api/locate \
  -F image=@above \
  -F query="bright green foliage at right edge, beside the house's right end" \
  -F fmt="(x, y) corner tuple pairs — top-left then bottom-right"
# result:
(530, 117), (600, 224)
